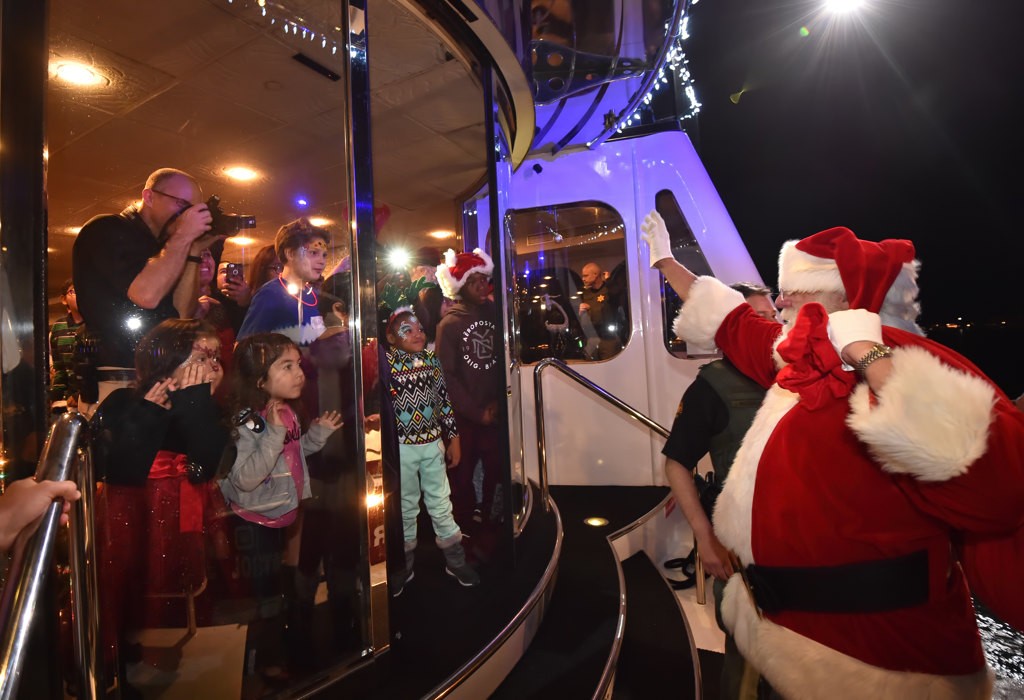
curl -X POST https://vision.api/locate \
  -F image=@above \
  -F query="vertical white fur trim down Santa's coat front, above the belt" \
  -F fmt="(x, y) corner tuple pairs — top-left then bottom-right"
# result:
(713, 385), (799, 566)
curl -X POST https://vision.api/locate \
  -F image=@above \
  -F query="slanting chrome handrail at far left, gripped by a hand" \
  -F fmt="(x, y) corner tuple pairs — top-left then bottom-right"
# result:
(0, 413), (88, 700)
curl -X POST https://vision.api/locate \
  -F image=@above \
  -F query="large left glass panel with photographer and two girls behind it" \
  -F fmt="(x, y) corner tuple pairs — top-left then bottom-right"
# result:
(46, 0), (372, 698)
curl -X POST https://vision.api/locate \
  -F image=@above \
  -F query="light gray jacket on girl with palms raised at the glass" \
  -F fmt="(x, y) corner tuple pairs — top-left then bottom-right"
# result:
(220, 424), (333, 520)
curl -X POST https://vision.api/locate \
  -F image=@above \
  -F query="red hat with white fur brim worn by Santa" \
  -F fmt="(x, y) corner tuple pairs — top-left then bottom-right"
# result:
(778, 226), (916, 313)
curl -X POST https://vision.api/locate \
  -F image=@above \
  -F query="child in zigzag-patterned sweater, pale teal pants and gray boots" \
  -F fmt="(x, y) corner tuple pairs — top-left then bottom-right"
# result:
(385, 306), (480, 596)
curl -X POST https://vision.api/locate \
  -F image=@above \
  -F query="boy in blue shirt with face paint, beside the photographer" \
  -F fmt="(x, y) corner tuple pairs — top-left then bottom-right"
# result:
(238, 218), (331, 348)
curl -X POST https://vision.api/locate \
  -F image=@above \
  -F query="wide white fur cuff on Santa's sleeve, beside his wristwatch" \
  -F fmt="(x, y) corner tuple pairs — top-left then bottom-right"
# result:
(847, 346), (996, 481)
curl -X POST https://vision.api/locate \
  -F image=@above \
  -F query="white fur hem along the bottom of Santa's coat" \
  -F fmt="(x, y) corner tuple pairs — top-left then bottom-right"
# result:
(722, 581), (992, 700)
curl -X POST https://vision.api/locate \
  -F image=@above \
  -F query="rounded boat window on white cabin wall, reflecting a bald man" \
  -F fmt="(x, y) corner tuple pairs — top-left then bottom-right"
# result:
(508, 202), (631, 363)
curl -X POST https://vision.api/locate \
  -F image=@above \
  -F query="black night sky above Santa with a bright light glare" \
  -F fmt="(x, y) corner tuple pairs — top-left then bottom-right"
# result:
(686, 0), (1024, 393)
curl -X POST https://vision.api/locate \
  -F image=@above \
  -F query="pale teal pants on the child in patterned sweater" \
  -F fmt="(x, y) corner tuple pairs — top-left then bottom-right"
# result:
(398, 440), (459, 542)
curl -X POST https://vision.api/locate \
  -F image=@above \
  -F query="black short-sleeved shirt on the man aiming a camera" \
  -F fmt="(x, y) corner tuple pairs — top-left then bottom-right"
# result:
(72, 207), (178, 367)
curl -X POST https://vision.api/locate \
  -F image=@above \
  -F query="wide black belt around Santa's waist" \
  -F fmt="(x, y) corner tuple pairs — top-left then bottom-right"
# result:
(745, 550), (928, 613)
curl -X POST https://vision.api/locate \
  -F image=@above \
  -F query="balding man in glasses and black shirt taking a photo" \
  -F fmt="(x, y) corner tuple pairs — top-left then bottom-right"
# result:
(72, 168), (223, 402)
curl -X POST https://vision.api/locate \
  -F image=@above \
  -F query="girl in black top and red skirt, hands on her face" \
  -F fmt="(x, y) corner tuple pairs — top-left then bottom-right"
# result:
(91, 318), (228, 682)
